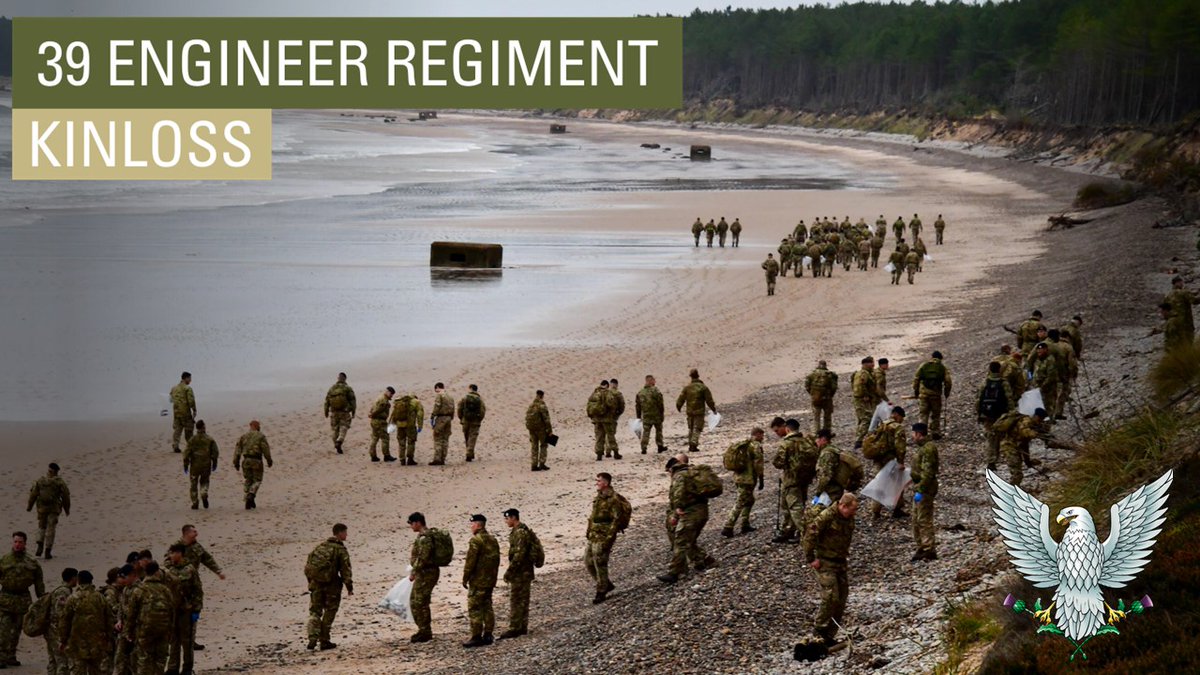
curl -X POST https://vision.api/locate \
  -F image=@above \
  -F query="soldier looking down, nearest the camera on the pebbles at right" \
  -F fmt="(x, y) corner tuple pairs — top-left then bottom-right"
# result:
(804, 492), (858, 643)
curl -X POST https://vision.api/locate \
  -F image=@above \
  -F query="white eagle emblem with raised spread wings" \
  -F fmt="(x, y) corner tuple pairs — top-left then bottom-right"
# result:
(988, 470), (1172, 643)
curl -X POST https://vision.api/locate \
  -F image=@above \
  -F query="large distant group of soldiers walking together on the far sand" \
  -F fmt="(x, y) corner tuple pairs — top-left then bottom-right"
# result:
(762, 214), (946, 295)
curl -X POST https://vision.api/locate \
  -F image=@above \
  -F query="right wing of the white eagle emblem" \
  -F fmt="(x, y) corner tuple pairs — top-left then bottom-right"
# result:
(1099, 471), (1174, 589)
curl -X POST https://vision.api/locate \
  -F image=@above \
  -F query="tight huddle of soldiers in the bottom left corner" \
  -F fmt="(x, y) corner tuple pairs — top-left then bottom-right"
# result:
(0, 525), (226, 675)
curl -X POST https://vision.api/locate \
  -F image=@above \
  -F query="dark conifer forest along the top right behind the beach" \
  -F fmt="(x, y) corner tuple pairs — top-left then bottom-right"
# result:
(684, 0), (1200, 126)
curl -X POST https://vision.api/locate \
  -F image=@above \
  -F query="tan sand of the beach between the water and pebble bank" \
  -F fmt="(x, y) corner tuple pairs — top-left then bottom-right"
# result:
(0, 115), (1056, 673)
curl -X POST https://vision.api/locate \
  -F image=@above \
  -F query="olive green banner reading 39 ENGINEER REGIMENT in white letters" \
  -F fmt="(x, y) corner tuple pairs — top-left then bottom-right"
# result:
(13, 18), (683, 109)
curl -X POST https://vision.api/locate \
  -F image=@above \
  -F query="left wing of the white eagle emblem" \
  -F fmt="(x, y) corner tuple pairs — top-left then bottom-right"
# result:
(988, 470), (1058, 589)
